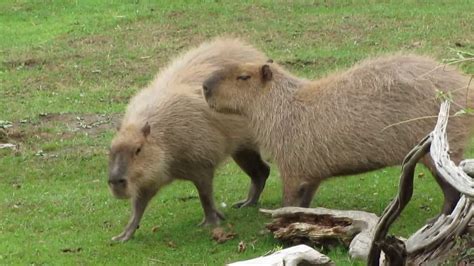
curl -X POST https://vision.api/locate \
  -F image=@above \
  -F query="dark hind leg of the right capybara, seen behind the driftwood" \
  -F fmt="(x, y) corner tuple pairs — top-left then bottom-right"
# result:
(423, 155), (460, 215)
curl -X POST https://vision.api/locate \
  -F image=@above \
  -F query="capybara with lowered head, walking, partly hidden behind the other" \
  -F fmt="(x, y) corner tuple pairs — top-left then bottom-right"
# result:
(108, 39), (270, 241)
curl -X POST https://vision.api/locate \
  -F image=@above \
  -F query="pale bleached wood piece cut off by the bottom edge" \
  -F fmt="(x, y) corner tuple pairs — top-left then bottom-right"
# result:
(228, 245), (334, 266)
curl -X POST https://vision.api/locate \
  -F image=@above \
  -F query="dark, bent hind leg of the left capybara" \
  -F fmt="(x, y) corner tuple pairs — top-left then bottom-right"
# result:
(232, 149), (270, 208)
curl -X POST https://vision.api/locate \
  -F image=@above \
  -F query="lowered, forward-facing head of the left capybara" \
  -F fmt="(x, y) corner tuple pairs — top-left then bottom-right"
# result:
(108, 123), (151, 199)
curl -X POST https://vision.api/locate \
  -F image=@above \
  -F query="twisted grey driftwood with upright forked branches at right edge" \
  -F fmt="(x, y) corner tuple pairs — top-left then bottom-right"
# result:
(368, 101), (474, 265)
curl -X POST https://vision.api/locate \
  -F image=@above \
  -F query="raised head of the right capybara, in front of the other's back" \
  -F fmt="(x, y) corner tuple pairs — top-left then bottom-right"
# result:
(202, 64), (273, 114)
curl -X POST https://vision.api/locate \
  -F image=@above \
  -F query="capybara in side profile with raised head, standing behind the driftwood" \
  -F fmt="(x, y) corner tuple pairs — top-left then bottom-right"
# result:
(203, 55), (474, 213)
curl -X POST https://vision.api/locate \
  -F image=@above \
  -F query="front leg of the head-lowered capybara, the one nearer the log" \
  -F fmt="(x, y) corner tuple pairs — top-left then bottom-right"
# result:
(194, 172), (224, 226)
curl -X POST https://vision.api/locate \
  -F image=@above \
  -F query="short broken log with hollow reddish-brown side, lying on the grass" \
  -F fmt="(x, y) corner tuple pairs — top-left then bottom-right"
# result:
(260, 207), (378, 260)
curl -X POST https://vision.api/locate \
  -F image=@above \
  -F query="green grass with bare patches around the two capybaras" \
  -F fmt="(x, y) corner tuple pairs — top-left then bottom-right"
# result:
(0, 0), (474, 265)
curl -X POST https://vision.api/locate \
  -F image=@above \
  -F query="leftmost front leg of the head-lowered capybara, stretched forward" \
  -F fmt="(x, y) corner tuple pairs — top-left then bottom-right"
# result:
(112, 189), (157, 242)
